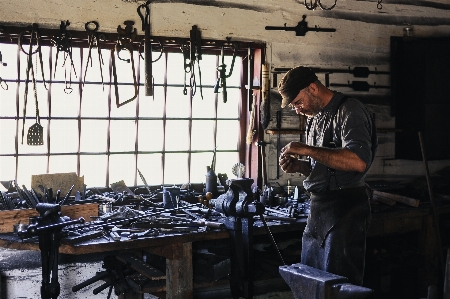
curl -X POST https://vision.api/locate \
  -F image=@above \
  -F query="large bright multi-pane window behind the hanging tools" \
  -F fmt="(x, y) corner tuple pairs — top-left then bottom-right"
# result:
(0, 34), (256, 187)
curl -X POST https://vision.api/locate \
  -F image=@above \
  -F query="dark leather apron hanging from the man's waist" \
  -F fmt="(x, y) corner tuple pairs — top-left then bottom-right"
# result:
(301, 187), (371, 285)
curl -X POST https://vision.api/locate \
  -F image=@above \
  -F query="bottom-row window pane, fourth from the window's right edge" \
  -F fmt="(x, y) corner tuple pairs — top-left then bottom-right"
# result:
(137, 154), (163, 185)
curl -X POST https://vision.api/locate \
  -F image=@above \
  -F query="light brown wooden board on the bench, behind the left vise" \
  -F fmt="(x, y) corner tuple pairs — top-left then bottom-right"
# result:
(0, 203), (98, 233)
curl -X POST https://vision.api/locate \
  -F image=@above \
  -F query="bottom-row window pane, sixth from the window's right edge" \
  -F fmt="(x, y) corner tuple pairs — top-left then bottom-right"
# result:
(80, 155), (108, 187)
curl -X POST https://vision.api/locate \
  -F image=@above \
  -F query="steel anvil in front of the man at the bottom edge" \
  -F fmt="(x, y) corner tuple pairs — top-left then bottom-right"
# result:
(278, 263), (372, 299)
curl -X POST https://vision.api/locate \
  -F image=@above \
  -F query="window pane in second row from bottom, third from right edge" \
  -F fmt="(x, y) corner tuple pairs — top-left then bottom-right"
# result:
(165, 120), (189, 151)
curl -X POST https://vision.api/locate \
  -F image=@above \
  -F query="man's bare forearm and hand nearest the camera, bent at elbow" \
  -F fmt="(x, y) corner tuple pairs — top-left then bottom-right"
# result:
(281, 142), (367, 172)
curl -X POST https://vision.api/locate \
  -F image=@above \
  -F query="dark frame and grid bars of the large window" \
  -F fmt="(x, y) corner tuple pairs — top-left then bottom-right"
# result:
(0, 27), (264, 187)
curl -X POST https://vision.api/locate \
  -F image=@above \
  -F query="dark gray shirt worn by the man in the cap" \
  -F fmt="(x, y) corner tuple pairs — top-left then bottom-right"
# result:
(303, 92), (375, 193)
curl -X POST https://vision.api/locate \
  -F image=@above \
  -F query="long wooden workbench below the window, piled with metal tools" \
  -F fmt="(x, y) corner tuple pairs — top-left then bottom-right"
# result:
(0, 214), (306, 299)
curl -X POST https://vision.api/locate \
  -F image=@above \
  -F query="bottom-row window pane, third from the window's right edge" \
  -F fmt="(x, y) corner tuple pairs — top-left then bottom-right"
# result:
(164, 153), (189, 184)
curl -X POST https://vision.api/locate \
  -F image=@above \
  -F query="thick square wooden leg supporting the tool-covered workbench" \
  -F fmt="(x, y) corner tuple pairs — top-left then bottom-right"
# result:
(166, 242), (194, 299)
